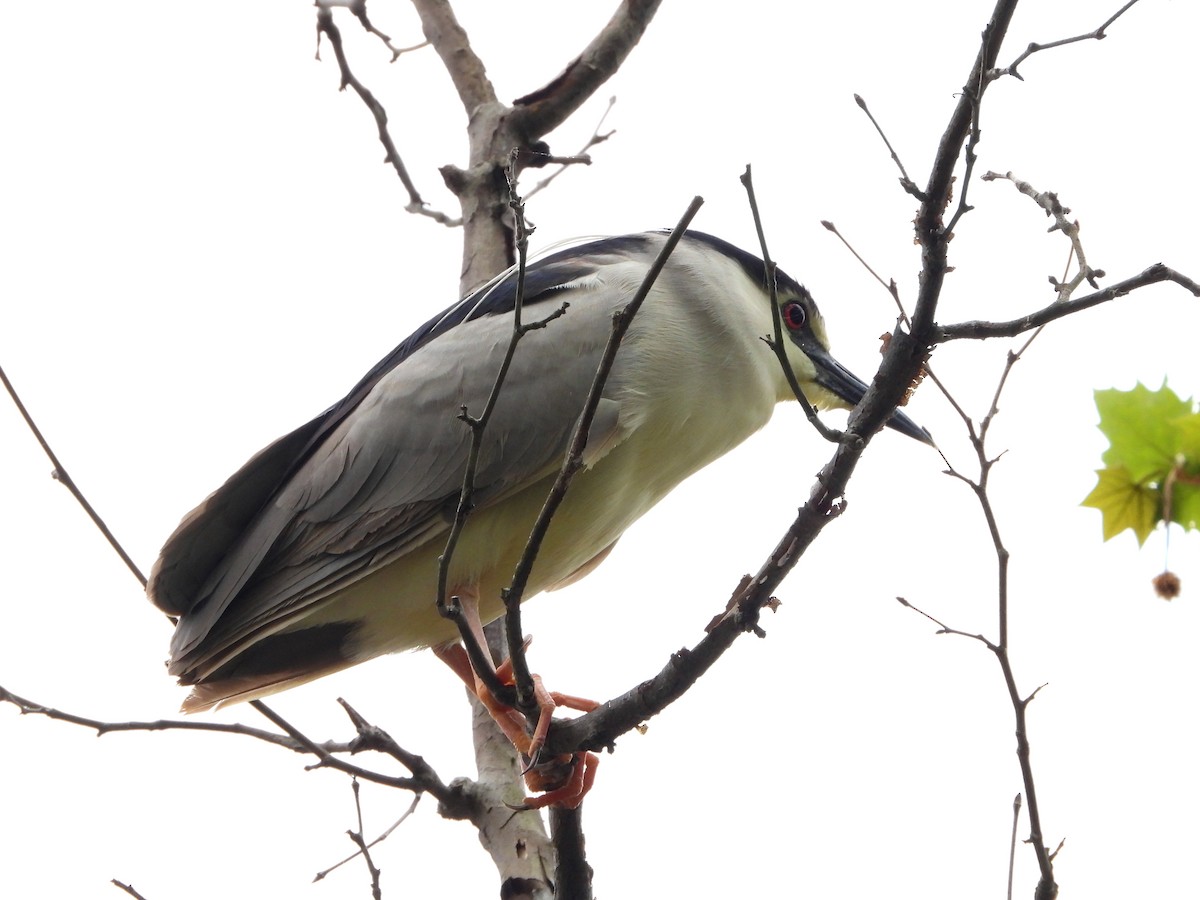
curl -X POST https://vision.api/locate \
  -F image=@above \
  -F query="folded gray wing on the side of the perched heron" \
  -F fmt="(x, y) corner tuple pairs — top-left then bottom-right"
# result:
(151, 247), (636, 673)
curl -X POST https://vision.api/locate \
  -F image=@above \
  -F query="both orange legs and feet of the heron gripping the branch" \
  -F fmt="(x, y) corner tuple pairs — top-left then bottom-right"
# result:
(433, 643), (600, 809)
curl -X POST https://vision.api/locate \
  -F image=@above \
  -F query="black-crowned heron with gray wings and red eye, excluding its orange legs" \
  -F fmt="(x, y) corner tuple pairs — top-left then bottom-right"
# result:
(149, 232), (928, 710)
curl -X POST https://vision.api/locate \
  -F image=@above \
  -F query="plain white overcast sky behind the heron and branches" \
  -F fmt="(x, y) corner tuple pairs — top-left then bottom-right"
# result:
(0, 0), (1200, 900)
